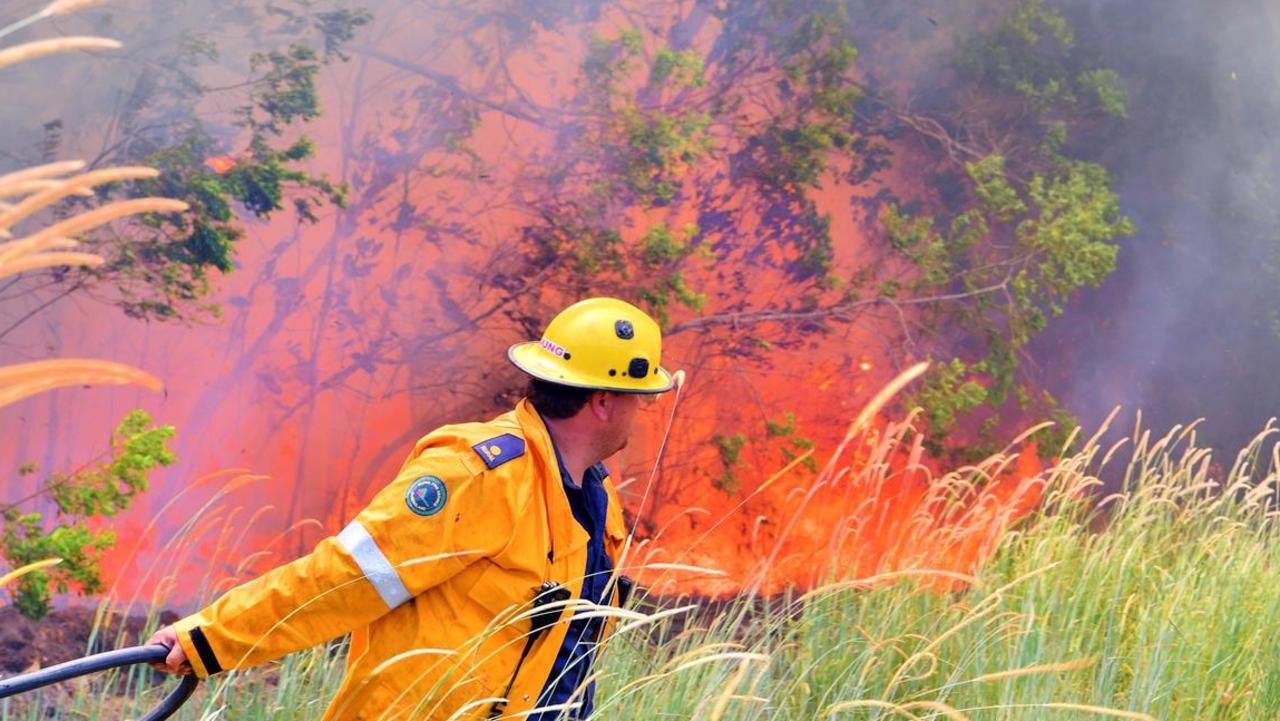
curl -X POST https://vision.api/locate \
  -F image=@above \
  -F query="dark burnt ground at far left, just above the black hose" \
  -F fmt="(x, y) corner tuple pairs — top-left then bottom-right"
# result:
(0, 606), (178, 676)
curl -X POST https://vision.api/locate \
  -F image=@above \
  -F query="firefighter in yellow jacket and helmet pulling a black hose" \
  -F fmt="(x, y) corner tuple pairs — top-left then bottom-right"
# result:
(151, 298), (673, 721)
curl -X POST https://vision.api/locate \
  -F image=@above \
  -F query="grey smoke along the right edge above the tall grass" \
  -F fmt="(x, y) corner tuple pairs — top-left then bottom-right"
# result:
(1036, 0), (1280, 451)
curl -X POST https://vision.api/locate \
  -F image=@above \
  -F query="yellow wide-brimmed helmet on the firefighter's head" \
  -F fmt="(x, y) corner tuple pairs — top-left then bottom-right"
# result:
(507, 298), (673, 393)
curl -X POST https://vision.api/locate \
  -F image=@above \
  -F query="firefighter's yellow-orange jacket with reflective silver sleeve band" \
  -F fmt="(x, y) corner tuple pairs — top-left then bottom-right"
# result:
(175, 400), (626, 721)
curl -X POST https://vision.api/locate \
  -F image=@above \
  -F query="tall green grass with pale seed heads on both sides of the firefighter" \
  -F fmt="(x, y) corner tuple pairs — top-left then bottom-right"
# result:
(10, 412), (1280, 721)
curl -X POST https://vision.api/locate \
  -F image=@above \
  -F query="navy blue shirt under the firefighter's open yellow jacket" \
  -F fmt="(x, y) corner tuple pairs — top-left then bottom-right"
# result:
(530, 442), (613, 721)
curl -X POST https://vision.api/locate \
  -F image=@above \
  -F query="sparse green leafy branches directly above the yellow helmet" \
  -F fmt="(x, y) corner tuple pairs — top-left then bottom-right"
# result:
(527, 29), (714, 320)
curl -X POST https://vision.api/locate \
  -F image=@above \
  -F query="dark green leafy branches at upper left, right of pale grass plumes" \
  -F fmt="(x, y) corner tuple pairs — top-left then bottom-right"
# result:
(113, 38), (347, 319)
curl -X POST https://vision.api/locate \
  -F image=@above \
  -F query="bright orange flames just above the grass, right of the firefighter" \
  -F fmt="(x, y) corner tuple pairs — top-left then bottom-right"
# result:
(628, 423), (1043, 597)
